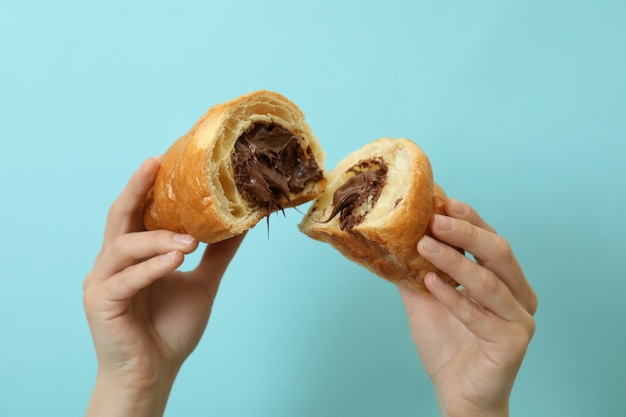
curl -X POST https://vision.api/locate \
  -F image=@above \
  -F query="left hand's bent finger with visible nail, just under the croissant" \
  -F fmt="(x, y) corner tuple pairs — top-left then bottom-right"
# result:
(91, 230), (198, 280)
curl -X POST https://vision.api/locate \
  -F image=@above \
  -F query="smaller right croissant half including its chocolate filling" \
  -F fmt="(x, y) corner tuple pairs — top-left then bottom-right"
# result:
(299, 138), (456, 290)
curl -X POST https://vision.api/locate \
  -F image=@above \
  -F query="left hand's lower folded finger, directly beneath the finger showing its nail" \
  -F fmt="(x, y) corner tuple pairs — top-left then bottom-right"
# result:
(104, 250), (185, 301)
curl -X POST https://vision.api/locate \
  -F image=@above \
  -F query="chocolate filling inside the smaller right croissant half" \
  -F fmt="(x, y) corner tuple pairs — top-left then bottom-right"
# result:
(326, 157), (388, 230)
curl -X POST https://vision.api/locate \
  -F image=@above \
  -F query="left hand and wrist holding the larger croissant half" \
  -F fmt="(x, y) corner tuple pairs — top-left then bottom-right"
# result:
(83, 159), (243, 416)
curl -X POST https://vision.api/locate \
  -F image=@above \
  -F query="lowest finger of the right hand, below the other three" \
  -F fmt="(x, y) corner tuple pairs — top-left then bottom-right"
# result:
(424, 272), (520, 341)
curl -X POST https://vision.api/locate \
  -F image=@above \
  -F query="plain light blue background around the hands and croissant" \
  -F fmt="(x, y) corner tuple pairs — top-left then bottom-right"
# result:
(0, 0), (626, 417)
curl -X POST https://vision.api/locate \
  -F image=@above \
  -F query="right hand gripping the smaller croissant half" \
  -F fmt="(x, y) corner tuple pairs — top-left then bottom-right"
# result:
(399, 199), (537, 417)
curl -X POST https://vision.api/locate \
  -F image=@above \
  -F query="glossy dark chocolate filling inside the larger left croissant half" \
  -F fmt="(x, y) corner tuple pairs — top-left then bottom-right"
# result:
(231, 123), (324, 214)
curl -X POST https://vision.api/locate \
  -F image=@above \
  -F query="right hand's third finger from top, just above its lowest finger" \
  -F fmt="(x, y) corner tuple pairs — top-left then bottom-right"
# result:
(417, 236), (523, 321)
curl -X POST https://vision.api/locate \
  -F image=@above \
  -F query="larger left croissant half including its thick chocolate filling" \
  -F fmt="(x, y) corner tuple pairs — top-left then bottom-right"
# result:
(143, 90), (326, 243)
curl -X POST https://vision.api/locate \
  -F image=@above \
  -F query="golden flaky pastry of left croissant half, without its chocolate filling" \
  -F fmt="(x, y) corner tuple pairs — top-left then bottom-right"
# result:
(143, 90), (326, 243)
